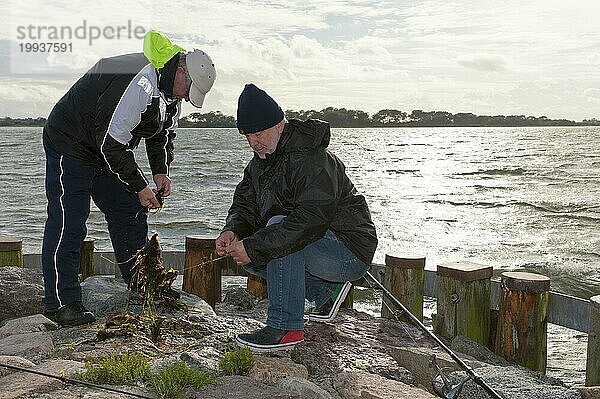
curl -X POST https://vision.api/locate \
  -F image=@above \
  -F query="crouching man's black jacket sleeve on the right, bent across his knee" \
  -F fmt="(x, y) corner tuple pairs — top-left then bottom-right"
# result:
(244, 151), (343, 265)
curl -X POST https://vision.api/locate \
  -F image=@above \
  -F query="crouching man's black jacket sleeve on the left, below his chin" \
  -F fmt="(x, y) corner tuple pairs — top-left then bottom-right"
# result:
(223, 165), (260, 239)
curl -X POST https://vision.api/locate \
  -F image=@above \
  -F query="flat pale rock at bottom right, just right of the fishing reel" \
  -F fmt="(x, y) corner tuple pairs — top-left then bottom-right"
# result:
(450, 366), (581, 399)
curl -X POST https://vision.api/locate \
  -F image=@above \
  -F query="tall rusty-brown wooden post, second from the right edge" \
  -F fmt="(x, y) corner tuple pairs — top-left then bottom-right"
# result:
(496, 272), (550, 373)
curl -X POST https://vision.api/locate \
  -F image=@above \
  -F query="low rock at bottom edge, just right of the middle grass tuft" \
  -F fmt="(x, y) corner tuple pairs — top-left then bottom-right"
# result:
(188, 375), (302, 399)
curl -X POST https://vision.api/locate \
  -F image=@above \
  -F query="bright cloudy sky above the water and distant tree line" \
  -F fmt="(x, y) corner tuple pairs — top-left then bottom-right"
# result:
(0, 0), (600, 121)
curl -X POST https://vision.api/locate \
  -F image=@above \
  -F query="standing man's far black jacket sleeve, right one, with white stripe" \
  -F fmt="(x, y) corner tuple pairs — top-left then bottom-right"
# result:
(145, 101), (181, 175)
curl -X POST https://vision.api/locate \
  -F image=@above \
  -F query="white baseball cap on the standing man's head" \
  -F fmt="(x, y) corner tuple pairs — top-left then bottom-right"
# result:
(185, 50), (217, 108)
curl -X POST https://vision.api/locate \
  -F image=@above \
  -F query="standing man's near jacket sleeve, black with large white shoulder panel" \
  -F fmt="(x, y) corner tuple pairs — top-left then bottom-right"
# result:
(95, 74), (152, 193)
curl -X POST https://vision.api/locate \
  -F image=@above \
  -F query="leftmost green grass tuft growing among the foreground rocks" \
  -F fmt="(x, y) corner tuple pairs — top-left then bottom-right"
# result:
(79, 353), (150, 385)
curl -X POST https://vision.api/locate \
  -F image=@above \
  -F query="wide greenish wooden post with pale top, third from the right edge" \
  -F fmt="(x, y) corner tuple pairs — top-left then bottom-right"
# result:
(433, 262), (493, 346)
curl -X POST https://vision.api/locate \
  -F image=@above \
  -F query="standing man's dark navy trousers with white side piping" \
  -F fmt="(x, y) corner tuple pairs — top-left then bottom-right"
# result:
(42, 142), (148, 310)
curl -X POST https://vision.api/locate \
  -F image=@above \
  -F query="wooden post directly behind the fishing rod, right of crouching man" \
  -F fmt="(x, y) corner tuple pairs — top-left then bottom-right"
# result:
(381, 254), (425, 321)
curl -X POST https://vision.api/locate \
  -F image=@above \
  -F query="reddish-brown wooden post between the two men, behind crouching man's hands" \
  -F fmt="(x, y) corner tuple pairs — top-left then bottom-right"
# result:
(183, 236), (226, 309)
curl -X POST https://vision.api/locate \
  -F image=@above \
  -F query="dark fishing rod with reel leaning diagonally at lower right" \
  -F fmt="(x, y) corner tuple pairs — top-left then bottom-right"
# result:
(367, 271), (504, 399)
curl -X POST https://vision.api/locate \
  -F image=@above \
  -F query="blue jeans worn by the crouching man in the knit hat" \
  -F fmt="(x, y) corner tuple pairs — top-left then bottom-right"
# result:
(244, 216), (369, 330)
